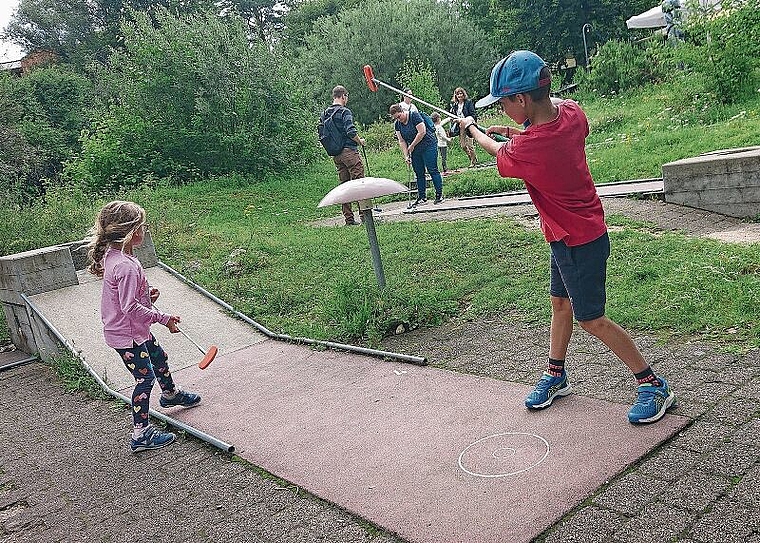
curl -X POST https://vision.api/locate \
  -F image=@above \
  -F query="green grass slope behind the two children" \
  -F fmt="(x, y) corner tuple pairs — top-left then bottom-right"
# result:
(0, 75), (760, 350)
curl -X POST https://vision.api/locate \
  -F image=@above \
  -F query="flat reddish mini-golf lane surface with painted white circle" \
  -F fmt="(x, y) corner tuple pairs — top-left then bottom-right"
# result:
(152, 340), (687, 543)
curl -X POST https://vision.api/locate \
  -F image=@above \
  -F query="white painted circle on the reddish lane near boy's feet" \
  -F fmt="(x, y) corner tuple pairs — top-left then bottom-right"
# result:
(458, 432), (549, 478)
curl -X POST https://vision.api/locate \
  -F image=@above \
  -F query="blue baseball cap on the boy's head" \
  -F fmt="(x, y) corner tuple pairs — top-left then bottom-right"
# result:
(475, 51), (551, 107)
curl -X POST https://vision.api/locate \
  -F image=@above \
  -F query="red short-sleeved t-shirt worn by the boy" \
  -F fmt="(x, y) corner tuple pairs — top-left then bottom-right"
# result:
(496, 100), (607, 247)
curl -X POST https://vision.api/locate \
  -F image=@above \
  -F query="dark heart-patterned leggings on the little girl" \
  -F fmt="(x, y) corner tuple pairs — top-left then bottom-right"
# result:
(116, 334), (174, 428)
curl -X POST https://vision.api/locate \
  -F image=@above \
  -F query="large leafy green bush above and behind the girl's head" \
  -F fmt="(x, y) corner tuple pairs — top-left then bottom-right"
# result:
(67, 9), (316, 190)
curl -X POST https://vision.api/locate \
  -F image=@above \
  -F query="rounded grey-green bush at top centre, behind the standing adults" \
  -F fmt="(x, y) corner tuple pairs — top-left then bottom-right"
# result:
(298, 0), (497, 123)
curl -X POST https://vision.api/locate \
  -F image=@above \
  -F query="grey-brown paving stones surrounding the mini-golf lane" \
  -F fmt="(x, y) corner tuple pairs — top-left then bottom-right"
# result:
(0, 200), (760, 543)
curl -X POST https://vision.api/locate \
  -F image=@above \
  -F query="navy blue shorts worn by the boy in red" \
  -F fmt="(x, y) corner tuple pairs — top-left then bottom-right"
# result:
(549, 232), (610, 321)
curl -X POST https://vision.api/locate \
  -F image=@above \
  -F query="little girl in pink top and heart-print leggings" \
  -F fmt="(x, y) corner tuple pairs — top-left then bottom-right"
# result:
(88, 201), (201, 452)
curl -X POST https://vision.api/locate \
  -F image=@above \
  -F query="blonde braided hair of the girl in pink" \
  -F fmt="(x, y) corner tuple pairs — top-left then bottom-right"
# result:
(87, 200), (146, 277)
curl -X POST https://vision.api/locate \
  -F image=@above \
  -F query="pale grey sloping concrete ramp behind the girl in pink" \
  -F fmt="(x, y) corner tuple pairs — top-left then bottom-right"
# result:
(31, 267), (266, 390)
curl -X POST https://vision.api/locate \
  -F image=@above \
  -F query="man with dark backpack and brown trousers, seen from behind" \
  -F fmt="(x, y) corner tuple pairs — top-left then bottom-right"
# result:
(318, 85), (365, 225)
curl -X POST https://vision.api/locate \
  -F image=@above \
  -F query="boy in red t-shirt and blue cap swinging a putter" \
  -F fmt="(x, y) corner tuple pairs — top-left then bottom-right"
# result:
(459, 51), (675, 424)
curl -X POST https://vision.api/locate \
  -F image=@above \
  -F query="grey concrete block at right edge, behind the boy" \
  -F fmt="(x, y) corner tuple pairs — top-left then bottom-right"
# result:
(662, 147), (760, 218)
